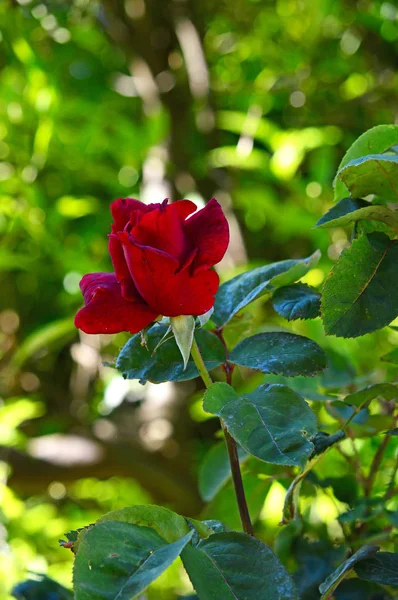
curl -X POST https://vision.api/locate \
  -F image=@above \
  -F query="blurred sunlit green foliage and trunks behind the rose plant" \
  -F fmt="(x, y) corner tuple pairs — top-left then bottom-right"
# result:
(0, 0), (398, 599)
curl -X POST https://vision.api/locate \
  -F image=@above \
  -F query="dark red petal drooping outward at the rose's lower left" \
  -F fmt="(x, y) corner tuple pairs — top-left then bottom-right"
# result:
(75, 273), (159, 333)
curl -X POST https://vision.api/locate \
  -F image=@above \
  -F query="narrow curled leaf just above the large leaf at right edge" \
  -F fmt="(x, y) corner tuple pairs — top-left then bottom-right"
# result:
(315, 198), (398, 228)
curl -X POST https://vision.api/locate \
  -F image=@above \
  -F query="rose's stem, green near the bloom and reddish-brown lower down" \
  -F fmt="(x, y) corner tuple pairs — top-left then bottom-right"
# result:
(191, 338), (254, 535)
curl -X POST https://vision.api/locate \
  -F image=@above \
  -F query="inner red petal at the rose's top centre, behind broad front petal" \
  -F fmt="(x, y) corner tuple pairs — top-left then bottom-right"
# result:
(131, 200), (196, 259)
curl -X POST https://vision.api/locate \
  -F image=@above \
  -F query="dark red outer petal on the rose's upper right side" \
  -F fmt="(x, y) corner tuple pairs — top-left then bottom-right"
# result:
(184, 198), (229, 271)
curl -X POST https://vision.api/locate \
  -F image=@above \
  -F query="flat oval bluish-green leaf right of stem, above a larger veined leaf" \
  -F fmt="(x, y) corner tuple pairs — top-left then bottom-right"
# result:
(228, 332), (326, 377)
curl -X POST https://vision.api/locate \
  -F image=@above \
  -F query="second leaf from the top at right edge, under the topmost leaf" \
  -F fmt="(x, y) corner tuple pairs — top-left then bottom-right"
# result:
(337, 154), (398, 202)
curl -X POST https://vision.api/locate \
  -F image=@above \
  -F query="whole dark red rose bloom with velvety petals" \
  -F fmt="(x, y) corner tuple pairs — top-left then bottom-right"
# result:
(75, 198), (229, 333)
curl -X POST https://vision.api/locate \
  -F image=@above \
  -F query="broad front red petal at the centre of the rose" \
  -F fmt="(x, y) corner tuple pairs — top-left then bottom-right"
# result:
(119, 233), (219, 317)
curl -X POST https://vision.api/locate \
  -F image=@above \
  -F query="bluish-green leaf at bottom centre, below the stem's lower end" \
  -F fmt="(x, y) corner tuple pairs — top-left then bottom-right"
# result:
(181, 532), (299, 600)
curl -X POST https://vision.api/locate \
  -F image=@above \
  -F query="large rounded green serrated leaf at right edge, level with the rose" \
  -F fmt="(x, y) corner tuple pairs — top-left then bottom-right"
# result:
(321, 233), (398, 337)
